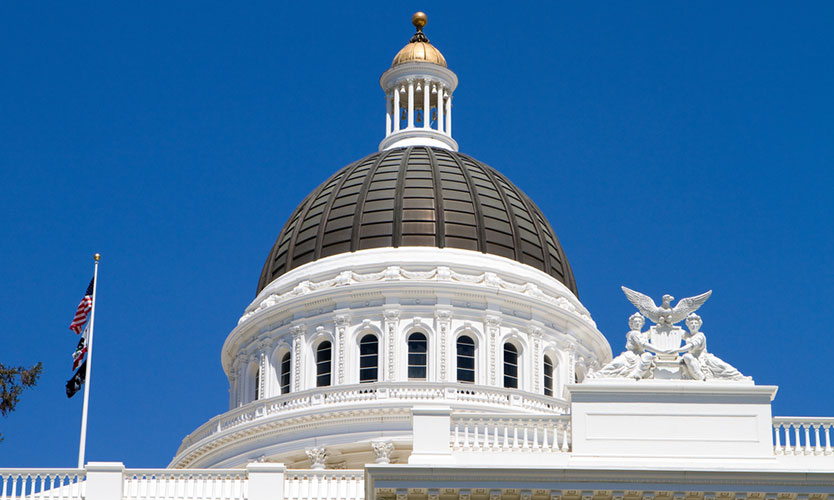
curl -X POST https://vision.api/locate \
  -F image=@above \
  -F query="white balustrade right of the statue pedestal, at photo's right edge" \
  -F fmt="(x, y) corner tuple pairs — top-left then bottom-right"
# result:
(773, 417), (834, 455)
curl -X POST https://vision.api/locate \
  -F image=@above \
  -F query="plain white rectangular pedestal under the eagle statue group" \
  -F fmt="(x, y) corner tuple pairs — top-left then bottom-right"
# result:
(567, 380), (777, 458)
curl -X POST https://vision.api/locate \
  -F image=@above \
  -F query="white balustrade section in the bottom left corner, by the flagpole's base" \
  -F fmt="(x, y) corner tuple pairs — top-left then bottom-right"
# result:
(0, 469), (85, 500)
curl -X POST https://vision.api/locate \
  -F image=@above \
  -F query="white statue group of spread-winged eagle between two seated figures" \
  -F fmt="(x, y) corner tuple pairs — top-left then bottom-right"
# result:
(588, 287), (750, 381)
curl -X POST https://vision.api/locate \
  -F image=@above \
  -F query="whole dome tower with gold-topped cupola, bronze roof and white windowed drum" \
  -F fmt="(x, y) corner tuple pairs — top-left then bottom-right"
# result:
(170, 13), (611, 469)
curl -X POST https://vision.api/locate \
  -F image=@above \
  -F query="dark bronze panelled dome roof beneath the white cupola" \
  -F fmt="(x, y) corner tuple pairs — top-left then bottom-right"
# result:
(258, 146), (577, 294)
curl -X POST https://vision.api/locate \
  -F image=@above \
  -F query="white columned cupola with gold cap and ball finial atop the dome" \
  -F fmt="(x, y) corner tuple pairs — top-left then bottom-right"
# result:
(379, 12), (458, 151)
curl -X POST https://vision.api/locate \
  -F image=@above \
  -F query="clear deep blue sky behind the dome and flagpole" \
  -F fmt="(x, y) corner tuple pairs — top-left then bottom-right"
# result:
(0, 1), (834, 467)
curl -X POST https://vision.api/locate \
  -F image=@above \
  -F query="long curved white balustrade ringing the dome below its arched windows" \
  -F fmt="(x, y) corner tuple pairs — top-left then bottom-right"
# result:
(180, 382), (568, 451)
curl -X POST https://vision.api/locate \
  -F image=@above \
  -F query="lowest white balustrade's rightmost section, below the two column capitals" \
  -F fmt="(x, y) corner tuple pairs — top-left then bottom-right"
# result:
(284, 470), (365, 500)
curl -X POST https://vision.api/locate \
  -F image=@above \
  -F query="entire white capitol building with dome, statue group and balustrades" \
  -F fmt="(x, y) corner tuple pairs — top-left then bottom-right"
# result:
(0, 13), (834, 500)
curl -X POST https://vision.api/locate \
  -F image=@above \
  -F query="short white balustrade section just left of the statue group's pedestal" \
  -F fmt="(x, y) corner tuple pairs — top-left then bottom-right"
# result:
(451, 414), (570, 453)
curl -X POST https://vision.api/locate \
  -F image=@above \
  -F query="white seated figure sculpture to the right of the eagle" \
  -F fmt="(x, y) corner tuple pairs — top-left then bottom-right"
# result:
(669, 313), (749, 380)
